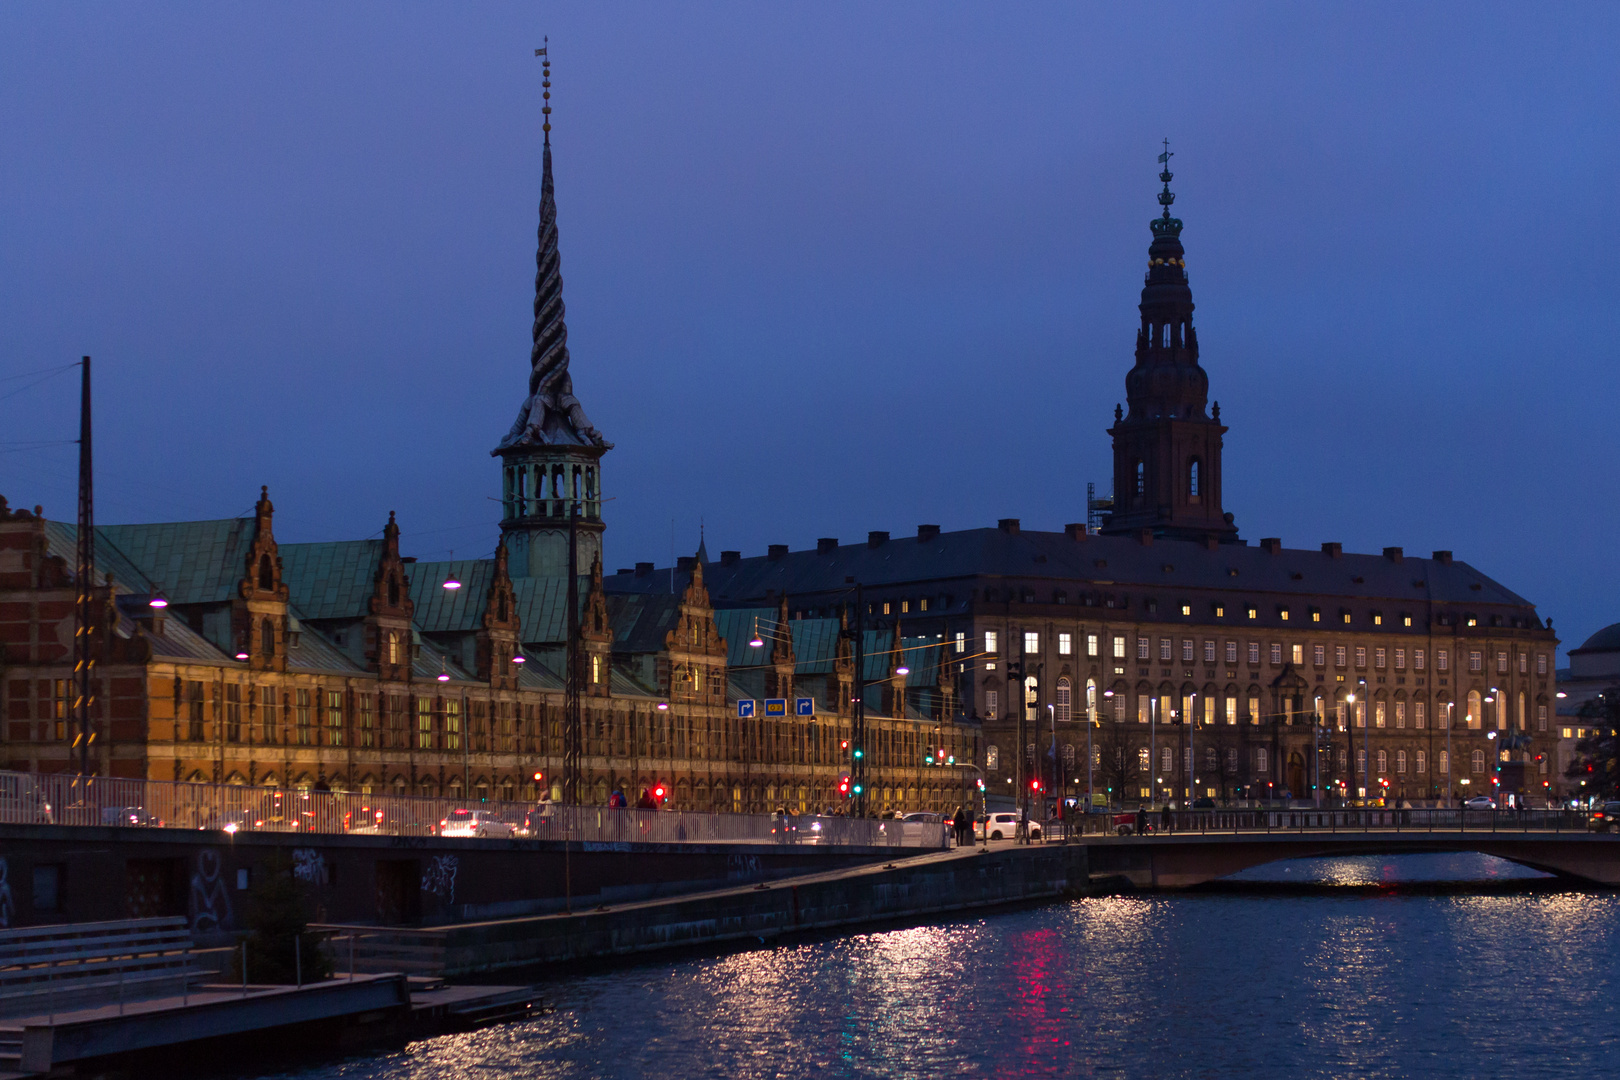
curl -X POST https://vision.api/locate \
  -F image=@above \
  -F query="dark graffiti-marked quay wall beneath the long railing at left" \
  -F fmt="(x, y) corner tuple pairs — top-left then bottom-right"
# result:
(0, 824), (917, 946)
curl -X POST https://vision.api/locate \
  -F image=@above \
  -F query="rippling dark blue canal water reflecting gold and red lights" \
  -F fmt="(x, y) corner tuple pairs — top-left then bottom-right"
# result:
(272, 855), (1620, 1080)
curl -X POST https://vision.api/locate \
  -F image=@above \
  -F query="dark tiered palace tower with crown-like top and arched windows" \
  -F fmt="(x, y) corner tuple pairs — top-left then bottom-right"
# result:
(1102, 141), (1238, 541)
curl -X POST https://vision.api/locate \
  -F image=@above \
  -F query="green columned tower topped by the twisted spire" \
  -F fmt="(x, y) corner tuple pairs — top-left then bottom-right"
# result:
(491, 49), (612, 578)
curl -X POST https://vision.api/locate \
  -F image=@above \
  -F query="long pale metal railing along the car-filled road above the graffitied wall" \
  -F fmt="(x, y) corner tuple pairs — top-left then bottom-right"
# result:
(0, 772), (949, 848)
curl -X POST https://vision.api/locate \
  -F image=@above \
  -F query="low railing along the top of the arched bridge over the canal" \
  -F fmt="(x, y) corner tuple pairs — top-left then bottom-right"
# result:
(1048, 806), (1588, 840)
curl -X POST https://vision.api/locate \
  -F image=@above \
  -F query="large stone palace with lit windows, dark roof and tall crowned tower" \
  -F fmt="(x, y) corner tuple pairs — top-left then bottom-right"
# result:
(618, 154), (1557, 805)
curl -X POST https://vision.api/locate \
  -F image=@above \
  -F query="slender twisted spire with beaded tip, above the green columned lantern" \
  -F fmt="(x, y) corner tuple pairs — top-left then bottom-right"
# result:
(494, 47), (612, 453)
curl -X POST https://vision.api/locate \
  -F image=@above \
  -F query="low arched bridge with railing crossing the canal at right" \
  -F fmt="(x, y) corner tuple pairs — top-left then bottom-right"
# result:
(1076, 808), (1620, 889)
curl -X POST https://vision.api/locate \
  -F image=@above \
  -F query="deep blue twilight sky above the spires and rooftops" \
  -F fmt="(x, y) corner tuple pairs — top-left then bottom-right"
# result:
(0, 2), (1620, 660)
